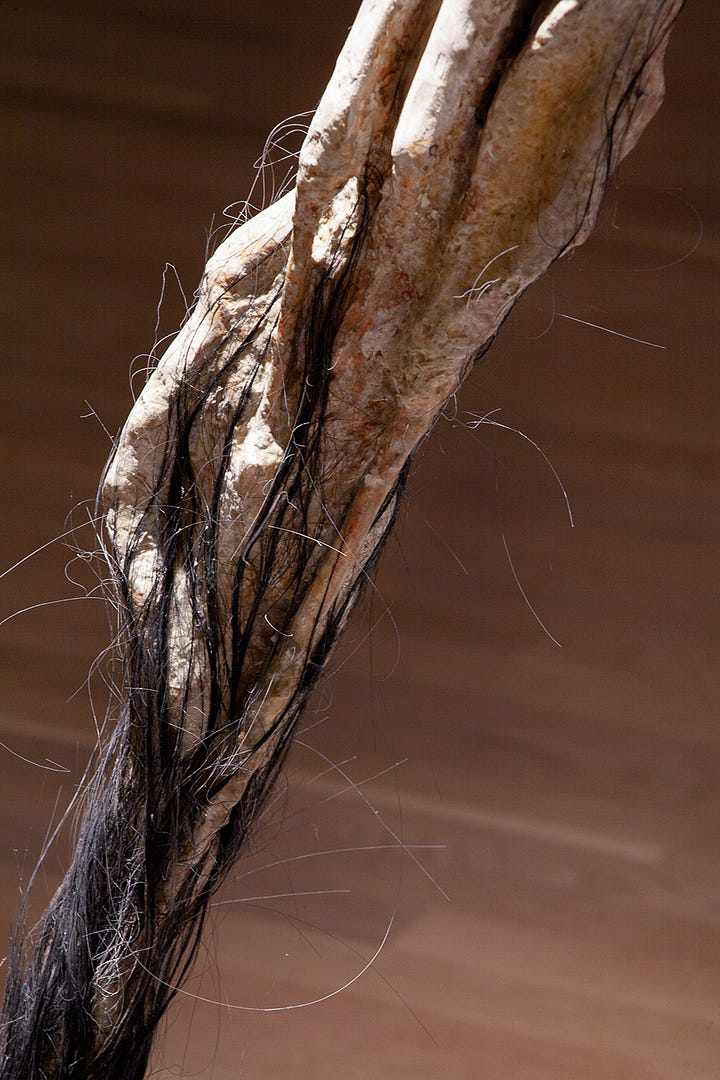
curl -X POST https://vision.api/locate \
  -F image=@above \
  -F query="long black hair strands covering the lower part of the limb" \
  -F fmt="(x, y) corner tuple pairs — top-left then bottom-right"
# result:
(0, 164), (406, 1080)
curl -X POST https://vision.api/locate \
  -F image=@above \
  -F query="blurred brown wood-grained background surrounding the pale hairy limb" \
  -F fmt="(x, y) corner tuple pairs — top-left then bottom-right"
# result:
(0, 0), (720, 1080)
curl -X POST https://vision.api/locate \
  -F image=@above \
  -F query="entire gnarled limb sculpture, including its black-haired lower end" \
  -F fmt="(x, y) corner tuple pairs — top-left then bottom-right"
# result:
(1, 0), (681, 1080)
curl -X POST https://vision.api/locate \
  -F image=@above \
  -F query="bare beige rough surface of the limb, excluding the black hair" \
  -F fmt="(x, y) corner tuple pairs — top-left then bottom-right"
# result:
(105, 0), (679, 868)
